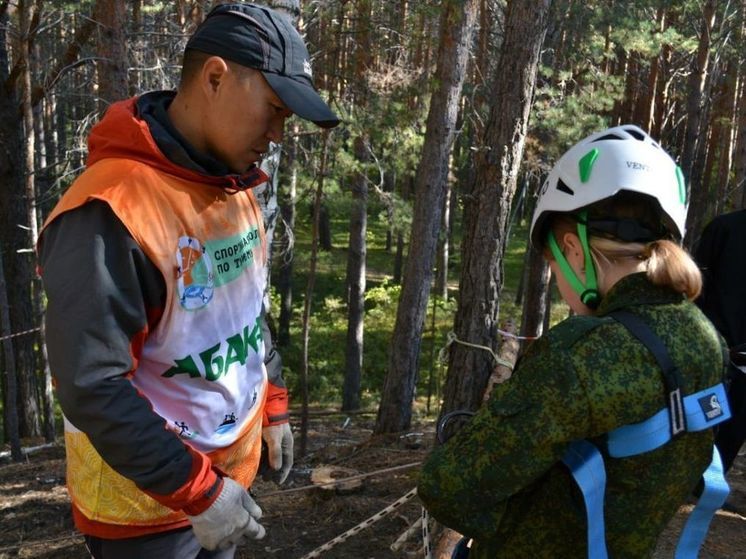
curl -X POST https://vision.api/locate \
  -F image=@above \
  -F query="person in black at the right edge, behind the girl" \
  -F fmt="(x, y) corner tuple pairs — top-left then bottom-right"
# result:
(695, 210), (746, 471)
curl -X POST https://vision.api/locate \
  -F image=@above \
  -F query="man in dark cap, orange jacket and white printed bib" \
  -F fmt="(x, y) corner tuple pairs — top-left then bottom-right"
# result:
(39, 4), (339, 559)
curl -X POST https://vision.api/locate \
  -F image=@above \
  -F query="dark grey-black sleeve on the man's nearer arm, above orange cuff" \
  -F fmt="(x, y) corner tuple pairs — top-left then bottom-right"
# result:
(38, 201), (192, 495)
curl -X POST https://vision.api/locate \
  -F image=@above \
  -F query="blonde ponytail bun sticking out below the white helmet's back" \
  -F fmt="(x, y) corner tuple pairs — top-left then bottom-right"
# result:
(643, 240), (702, 301)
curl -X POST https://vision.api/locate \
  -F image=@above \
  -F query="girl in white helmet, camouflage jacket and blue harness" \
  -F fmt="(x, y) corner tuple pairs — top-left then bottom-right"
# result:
(418, 125), (729, 559)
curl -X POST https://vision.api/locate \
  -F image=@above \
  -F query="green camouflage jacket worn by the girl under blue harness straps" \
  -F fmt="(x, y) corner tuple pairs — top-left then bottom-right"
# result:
(418, 274), (723, 559)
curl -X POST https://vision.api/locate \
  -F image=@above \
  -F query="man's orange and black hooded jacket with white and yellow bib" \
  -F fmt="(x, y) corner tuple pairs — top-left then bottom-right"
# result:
(39, 92), (287, 538)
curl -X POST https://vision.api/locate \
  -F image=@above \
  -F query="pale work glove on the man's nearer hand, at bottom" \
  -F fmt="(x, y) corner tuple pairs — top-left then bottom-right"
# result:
(187, 477), (264, 551)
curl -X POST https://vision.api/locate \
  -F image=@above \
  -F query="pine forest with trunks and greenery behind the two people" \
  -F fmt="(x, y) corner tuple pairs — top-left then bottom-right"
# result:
(0, 0), (746, 459)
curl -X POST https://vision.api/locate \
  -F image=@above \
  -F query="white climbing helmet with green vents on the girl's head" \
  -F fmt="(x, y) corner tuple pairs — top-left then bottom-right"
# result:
(531, 124), (687, 246)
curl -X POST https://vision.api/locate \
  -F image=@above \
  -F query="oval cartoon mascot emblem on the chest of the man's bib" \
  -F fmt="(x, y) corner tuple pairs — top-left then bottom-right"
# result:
(176, 237), (215, 311)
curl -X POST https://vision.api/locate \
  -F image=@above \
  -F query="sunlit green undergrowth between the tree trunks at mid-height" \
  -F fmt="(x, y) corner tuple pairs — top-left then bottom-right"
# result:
(271, 210), (567, 412)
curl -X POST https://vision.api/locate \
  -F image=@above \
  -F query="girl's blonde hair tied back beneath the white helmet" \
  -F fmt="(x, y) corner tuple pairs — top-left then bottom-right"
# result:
(545, 214), (702, 300)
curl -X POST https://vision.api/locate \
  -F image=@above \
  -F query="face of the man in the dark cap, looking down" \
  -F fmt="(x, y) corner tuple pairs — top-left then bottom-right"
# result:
(202, 63), (292, 174)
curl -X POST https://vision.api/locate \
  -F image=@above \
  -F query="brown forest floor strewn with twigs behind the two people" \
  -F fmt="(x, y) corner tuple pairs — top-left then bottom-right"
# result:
(0, 416), (746, 559)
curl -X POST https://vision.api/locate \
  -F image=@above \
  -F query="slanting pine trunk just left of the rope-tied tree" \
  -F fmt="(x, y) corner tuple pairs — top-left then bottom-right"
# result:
(375, 0), (477, 433)
